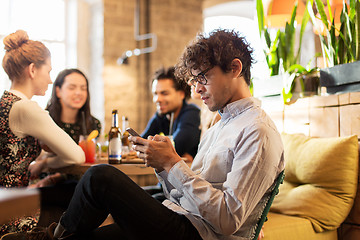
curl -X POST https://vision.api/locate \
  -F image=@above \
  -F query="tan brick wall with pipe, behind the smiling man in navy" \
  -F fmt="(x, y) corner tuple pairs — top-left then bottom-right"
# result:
(103, 0), (203, 133)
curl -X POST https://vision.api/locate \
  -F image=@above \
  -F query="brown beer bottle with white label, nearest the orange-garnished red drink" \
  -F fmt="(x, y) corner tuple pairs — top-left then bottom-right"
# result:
(108, 110), (122, 164)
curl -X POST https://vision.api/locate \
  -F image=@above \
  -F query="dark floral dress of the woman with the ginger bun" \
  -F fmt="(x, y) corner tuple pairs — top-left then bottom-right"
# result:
(0, 91), (41, 236)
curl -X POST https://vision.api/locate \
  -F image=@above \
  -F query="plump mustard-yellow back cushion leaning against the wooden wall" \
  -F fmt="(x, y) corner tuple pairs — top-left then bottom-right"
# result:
(271, 134), (358, 232)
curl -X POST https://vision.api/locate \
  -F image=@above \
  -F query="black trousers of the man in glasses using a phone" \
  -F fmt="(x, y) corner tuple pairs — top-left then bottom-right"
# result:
(61, 164), (201, 240)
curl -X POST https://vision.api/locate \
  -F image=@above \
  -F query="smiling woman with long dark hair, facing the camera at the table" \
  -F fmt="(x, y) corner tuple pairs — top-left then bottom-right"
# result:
(46, 68), (101, 142)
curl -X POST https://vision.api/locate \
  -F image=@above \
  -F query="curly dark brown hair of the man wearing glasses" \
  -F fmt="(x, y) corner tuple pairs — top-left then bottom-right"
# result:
(175, 29), (254, 85)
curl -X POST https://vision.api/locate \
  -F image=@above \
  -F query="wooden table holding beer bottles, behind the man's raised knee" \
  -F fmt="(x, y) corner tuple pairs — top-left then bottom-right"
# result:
(50, 158), (158, 186)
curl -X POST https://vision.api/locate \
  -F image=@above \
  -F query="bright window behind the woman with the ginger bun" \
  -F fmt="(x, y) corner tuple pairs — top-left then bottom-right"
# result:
(0, 0), (77, 108)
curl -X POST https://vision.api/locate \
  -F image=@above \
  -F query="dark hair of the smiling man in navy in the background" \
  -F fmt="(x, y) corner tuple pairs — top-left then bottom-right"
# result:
(151, 67), (191, 99)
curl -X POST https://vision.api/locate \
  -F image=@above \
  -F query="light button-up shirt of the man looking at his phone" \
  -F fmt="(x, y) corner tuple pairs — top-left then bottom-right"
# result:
(158, 97), (284, 240)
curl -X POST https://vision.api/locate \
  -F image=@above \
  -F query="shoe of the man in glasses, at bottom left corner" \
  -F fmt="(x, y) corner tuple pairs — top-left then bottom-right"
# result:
(1, 223), (57, 240)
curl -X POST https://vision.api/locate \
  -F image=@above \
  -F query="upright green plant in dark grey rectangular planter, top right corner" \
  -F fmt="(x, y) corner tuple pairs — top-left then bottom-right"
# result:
(308, 0), (360, 94)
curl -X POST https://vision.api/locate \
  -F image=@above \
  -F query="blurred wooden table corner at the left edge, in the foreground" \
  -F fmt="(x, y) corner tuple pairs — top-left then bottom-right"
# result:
(0, 188), (40, 224)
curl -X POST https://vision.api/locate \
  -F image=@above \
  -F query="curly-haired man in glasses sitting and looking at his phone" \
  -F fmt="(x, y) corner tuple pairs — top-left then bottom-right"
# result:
(4, 30), (284, 240)
